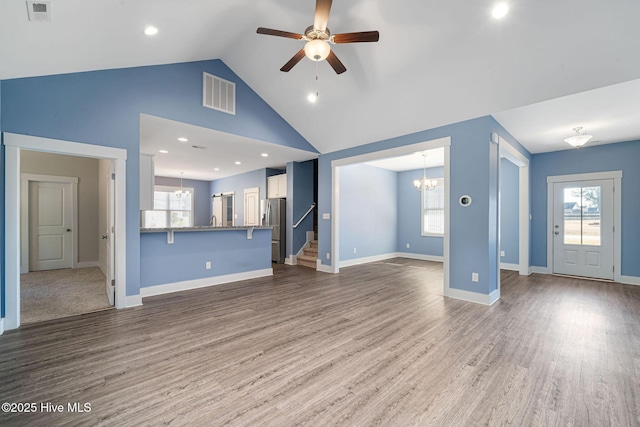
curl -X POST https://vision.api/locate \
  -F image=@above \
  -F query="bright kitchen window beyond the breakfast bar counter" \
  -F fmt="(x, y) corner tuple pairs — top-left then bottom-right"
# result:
(142, 185), (194, 228)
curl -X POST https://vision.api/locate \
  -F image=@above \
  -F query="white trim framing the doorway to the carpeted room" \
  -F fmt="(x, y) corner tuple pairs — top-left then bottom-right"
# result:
(4, 133), (127, 329)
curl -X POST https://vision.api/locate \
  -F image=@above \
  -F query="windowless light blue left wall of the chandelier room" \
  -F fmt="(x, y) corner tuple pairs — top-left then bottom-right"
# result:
(340, 164), (398, 261)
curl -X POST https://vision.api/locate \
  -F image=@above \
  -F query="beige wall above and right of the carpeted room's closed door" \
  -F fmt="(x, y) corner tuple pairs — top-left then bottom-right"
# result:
(20, 151), (99, 262)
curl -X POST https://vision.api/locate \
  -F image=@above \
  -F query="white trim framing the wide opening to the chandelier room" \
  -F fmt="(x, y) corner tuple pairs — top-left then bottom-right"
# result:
(332, 136), (457, 297)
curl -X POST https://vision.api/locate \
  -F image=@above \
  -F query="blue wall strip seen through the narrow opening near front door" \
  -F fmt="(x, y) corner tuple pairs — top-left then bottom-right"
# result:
(500, 159), (520, 264)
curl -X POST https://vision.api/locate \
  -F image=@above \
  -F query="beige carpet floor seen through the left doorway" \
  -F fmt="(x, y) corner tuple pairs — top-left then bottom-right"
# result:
(20, 267), (111, 324)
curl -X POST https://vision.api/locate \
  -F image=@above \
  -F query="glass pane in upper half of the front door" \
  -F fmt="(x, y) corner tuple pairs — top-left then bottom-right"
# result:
(563, 186), (602, 246)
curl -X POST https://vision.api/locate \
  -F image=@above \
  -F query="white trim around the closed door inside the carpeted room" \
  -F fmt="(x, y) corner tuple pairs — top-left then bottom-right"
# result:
(20, 173), (78, 274)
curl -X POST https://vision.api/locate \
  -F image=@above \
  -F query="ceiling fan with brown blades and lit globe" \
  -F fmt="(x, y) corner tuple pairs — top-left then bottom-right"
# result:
(257, 0), (380, 74)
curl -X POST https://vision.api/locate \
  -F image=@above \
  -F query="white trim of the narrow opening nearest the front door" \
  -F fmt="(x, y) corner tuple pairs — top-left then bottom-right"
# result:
(498, 136), (531, 278)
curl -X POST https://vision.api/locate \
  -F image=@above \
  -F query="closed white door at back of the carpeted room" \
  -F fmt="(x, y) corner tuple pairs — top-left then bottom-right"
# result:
(29, 181), (74, 271)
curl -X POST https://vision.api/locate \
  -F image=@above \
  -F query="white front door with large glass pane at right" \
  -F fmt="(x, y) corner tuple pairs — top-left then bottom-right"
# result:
(552, 179), (614, 280)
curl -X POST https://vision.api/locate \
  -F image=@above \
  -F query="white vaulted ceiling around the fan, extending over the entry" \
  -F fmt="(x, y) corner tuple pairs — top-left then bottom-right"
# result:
(0, 0), (640, 167)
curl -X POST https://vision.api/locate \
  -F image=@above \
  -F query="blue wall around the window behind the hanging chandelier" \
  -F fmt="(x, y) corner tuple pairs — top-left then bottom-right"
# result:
(397, 167), (444, 257)
